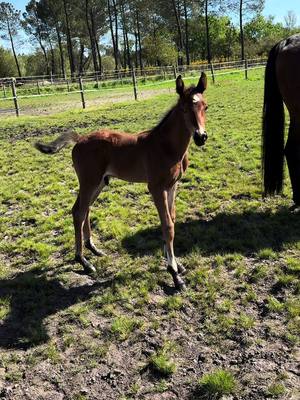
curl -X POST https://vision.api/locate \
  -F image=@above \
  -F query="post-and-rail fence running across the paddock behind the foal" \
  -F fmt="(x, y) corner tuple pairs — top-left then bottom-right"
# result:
(0, 58), (266, 116)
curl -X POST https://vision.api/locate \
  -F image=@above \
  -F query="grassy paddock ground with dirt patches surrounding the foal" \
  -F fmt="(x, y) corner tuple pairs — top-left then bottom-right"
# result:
(0, 72), (300, 400)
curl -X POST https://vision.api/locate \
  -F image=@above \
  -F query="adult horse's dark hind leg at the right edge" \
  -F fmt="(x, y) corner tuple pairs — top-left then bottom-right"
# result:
(285, 119), (300, 206)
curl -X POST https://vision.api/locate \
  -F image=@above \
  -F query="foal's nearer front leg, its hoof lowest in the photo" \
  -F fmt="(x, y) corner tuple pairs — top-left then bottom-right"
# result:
(149, 186), (185, 290)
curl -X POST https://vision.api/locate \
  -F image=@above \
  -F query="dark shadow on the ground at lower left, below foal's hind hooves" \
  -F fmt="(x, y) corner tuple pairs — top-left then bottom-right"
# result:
(0, 272), (111, 349)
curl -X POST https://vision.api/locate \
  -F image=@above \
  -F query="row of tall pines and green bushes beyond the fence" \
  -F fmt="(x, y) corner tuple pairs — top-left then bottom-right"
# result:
(0, 0), (299, 76)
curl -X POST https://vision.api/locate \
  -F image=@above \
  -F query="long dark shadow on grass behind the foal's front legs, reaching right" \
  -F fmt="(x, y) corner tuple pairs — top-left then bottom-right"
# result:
(122, 208), (300, 255)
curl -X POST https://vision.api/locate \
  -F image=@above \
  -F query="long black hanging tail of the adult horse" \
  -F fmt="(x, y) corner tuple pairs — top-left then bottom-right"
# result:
(262, 42), (284, 196)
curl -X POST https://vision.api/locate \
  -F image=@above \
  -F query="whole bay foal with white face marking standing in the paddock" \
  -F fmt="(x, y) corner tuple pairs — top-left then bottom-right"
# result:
(36, 73), (207, 290)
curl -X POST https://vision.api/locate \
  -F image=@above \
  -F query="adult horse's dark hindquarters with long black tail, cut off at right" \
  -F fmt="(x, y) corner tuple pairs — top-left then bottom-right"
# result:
(262, 34), (300, 207)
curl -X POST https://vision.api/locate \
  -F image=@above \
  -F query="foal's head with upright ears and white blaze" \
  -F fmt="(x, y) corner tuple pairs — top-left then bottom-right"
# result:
(176, 72), (207, 146)
